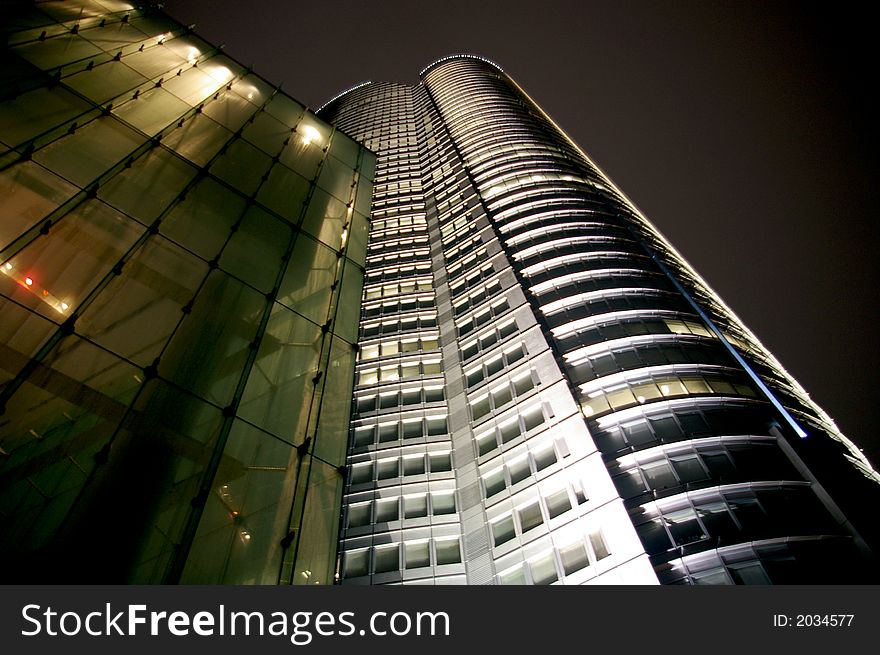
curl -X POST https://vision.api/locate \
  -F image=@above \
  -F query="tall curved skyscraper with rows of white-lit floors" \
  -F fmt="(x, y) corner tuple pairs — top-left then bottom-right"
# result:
(318, 55), (878, 584)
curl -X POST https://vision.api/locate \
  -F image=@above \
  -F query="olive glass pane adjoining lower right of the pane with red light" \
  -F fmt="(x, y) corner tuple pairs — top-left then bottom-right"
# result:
(77, 236), (208, 366)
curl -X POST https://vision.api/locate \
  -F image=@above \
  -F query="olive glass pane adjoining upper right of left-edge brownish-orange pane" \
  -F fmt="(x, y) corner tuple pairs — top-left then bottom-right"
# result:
(34, 117), (144, 186)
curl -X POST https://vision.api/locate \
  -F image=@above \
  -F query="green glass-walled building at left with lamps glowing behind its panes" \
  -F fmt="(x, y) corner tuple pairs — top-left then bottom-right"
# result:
(0, 0), (375, 584)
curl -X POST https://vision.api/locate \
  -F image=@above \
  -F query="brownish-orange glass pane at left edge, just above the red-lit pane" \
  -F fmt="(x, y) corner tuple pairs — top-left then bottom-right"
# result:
(0, 161), (77, 249)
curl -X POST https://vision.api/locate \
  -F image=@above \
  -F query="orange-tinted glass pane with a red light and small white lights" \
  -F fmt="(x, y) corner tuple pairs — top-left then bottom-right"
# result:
(0, 201), (143, 322)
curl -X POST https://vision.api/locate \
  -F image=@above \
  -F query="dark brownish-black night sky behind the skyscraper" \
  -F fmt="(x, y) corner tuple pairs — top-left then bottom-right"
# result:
(165, 0), (880, 463)
